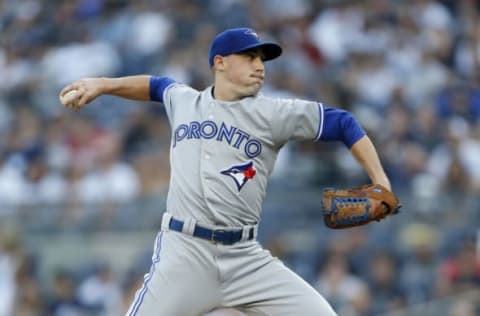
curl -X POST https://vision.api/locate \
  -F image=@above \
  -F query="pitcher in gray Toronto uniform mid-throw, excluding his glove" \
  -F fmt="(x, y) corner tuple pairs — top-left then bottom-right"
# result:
(60, 28), (398, 316)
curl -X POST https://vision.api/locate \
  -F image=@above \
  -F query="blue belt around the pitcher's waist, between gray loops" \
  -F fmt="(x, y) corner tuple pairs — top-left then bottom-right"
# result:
(168, 218), (255, 245)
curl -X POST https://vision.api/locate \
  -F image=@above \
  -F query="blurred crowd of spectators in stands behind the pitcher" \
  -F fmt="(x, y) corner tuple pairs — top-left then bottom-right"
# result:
(0, 0), (480, 316)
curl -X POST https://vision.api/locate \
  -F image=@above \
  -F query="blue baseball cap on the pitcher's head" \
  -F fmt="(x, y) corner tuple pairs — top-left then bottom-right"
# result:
(208, 27), (282, 67)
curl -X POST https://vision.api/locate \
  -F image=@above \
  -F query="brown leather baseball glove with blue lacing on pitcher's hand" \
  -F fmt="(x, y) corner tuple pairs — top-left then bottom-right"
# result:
(322, 184), (401, 229)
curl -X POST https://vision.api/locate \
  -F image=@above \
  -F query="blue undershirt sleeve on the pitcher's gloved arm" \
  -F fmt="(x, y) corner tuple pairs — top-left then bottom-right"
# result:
(320, 107), (365, 148)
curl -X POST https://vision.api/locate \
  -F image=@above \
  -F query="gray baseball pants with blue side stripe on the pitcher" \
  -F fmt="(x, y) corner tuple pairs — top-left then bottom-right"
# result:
(126, 214), (336, 316)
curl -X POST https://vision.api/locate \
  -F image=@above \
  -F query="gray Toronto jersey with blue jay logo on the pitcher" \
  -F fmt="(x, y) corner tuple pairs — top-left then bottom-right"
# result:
(163, 83), (323, 226)
